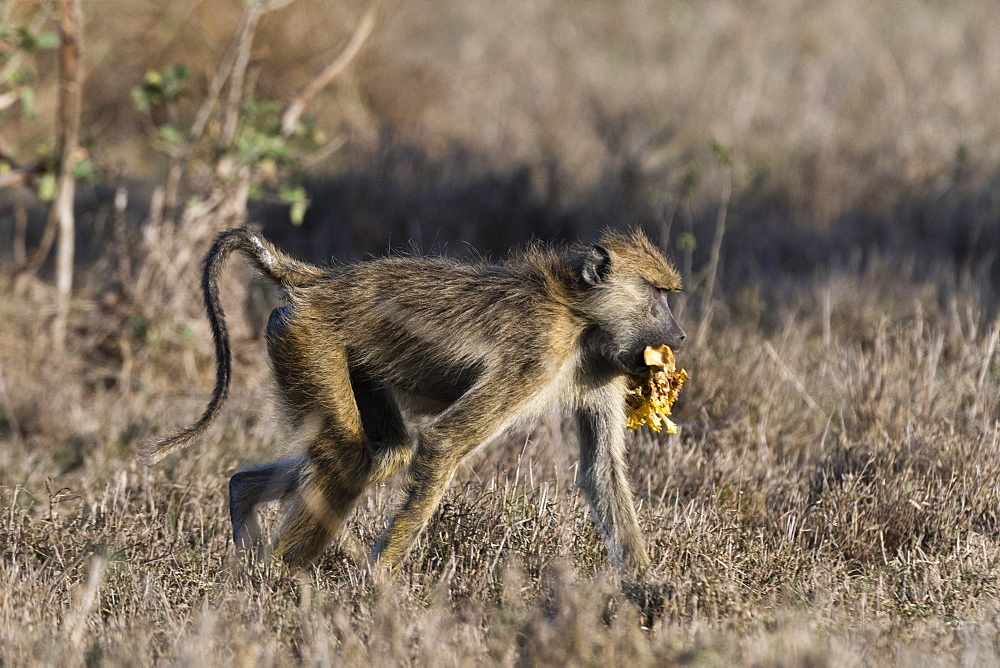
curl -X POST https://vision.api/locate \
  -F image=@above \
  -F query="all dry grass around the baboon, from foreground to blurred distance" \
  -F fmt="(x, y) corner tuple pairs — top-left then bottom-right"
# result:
(0, 0), (1000, 665)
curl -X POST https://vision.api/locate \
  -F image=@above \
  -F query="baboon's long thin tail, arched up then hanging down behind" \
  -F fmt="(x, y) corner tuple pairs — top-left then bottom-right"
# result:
(137, 227), (324, 465)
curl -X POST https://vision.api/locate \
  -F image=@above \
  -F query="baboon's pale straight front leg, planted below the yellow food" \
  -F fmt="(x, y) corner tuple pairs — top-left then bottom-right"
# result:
(576, 392), (649, 573)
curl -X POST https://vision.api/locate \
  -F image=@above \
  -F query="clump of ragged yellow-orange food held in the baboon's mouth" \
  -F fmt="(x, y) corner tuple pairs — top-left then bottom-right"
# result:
(626, 345), (690, 434)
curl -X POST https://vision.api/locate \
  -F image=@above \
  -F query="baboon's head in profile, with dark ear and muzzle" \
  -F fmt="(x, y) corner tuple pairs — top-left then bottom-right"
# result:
(581, 231), (687, 376)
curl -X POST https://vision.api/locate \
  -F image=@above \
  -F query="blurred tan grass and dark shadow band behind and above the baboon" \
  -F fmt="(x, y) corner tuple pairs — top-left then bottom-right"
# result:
(0, 0), (1000, 276)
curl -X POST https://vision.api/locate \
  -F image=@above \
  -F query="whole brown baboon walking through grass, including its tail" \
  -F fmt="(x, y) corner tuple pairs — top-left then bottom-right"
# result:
(140, 227), (685, 572)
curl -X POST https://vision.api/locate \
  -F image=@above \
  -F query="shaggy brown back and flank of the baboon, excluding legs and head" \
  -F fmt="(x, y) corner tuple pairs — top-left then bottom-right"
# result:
(289, 250), (567, 394)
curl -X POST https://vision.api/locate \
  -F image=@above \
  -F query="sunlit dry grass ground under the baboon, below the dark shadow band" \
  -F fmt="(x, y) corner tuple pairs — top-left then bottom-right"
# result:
(0, 250), (1000, 665)
